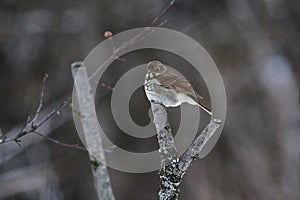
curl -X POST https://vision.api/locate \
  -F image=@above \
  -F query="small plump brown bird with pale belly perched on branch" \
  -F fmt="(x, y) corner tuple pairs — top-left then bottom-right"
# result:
(144, 60), (212, 115)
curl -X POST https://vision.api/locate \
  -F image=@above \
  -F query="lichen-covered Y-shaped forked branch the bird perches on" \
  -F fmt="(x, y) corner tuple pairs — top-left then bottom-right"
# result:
(151, 102), (221, 200)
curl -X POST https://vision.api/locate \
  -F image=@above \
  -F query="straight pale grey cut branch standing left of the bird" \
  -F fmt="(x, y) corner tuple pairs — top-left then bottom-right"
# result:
(71, 62), (115, 200)
